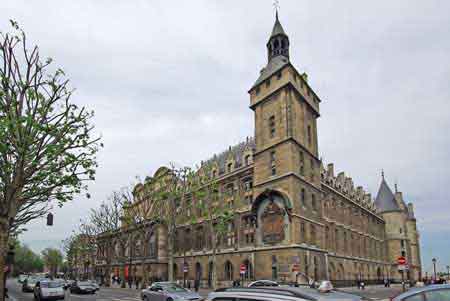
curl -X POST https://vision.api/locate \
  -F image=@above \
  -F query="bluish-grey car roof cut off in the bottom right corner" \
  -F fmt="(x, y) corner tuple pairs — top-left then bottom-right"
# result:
(391, 284), (450, 301)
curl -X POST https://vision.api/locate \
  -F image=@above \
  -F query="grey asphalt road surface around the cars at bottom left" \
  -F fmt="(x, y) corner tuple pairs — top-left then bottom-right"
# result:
(6, 279), (141, 301)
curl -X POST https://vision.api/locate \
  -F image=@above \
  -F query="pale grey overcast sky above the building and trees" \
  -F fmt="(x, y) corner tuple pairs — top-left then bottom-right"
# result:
(0, 0), (450, 270)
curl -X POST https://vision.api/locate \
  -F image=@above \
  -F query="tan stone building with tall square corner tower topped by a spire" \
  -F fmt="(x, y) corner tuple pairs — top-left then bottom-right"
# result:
(95, 14), (421, 286)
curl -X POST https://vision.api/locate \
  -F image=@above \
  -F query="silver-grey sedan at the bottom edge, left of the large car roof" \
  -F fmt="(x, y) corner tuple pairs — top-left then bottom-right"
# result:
(141, 282), (203, 301)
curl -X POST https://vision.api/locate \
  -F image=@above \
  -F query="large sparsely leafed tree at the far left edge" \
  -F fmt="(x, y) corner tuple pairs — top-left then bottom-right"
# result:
(0, 21), (100, 297)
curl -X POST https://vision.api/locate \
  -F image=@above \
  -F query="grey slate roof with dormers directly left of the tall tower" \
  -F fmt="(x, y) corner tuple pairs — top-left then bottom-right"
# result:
(205, 137), (256, 174)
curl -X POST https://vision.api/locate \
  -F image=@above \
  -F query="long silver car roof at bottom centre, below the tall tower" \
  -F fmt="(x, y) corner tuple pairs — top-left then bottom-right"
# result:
(207, 286), (368, 301)
